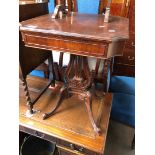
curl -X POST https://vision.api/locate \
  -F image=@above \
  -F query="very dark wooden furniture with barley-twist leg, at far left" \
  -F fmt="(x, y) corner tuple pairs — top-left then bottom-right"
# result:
(19, 1), (54, 114)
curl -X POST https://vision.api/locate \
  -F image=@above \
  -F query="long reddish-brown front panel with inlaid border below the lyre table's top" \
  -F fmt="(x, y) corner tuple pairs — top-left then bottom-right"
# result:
(24, 34), (107, 58)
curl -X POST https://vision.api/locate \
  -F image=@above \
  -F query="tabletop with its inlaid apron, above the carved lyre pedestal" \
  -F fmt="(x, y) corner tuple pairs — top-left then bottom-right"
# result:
(20, 13), (129, 59)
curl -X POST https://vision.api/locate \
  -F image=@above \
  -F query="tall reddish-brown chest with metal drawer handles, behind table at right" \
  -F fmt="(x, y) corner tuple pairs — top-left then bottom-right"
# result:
(106, 0), (135, 77)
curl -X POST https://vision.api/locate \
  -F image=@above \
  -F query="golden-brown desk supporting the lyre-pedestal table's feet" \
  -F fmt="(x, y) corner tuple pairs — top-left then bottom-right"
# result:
(19, 76), (112, 155)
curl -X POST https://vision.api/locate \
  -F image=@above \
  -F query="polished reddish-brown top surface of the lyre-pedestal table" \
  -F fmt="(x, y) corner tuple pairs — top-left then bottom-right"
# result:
(20, 12), (129, 41)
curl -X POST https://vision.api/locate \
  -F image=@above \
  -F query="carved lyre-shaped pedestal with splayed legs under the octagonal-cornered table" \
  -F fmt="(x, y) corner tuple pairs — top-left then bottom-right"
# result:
(43, 54), (100, 134)
